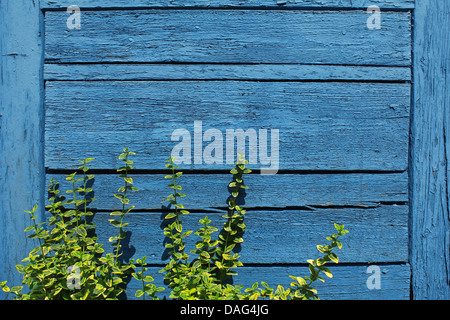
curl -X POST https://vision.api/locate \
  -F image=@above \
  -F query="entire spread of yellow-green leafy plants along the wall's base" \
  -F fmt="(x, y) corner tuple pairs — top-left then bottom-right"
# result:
(0, 148), (348, 300)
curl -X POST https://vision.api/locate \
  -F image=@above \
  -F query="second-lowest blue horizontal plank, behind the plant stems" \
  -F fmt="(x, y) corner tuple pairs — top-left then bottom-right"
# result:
(47, 205), (408, 264)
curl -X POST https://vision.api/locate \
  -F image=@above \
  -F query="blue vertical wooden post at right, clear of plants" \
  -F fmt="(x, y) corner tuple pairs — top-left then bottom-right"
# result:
(410, 0), (450, 299)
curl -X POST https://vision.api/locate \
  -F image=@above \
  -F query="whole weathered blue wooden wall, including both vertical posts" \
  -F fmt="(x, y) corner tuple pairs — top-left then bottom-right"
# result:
(0, 0), (450, 299)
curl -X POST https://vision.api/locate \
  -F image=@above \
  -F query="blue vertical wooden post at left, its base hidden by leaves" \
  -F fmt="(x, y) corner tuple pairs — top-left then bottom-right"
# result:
(0, 0), (45, 296)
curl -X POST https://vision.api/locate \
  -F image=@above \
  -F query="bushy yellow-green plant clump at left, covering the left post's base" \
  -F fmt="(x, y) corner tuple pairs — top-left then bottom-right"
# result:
(0, 148), (163, 300)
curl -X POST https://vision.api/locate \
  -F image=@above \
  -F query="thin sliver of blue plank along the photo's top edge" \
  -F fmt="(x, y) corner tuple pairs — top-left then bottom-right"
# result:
(41, 0), (414, 10)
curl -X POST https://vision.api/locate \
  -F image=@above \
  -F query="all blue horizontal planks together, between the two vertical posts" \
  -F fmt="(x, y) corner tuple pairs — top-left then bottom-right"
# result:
(41, 0), (414, 299)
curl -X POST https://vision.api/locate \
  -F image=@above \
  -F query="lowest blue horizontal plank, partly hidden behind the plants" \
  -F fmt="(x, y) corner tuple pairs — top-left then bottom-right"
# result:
(123, 264), (411, 300)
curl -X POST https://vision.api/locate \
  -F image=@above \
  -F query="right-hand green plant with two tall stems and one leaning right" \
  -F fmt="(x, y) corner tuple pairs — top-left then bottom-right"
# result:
(156, 155), (348, 300)
